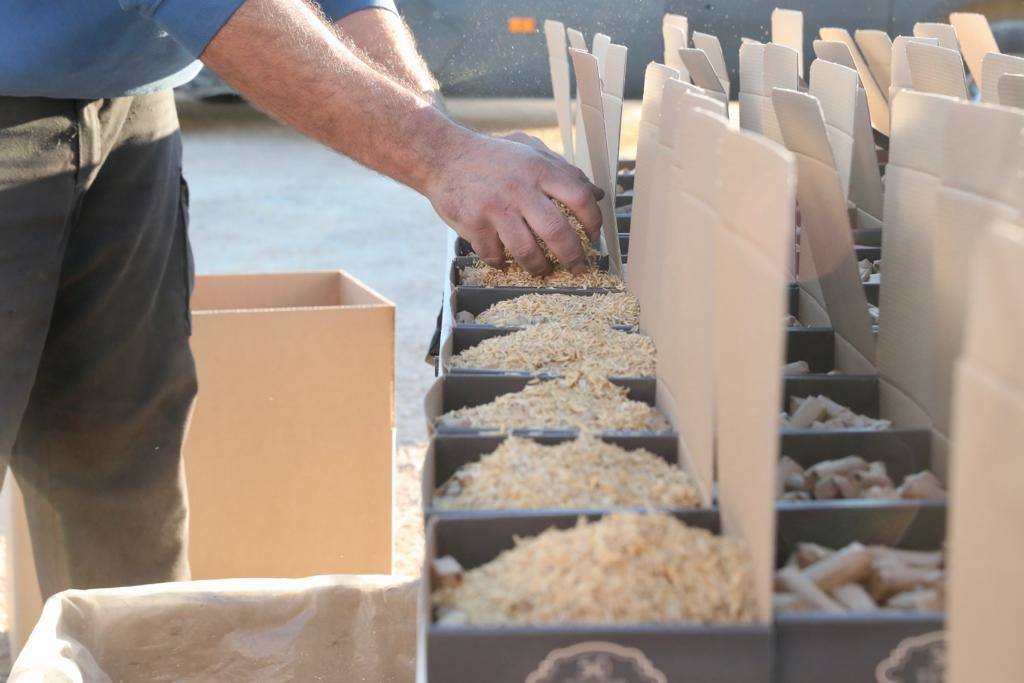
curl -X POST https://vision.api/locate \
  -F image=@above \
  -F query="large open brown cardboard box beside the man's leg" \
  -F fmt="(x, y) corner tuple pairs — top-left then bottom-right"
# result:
(184, 271), (394, 579)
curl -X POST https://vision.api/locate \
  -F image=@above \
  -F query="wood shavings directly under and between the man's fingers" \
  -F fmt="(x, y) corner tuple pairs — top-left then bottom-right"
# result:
(460, 200), (623, 289)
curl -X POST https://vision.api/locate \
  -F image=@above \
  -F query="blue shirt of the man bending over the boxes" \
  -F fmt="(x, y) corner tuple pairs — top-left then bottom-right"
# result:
(0, 0), (394, 99)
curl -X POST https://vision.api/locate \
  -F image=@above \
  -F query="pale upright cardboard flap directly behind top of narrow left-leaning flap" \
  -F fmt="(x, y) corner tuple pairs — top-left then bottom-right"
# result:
(739, 43), (800, 143)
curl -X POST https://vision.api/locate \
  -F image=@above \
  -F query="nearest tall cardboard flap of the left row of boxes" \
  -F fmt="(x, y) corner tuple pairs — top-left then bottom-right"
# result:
(714, 130), (796, 622)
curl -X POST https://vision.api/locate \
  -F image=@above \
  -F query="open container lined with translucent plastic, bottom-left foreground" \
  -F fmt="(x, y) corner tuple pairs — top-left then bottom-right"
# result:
(8, 575), (419, 683)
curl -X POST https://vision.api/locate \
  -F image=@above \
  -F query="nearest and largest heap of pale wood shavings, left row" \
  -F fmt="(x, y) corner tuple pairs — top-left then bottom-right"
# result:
(432, 513), (755, 625)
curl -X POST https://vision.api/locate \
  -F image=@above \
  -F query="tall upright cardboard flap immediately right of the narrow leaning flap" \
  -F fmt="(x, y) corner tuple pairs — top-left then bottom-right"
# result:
(877, 90), (957, 444)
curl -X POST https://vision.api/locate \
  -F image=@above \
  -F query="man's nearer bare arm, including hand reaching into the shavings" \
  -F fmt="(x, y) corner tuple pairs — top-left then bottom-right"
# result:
(201, 0), (601, 273)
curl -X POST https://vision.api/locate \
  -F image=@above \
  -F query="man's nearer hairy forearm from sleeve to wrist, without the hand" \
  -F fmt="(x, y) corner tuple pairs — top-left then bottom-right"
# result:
(202, 0), (470, 194)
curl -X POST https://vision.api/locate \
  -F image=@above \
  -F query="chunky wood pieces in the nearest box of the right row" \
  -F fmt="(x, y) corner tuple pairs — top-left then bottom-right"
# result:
(775, 543), (945, 612)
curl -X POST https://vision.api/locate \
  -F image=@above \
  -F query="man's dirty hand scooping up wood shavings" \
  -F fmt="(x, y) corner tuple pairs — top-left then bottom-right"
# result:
(427, 134), (601, 274)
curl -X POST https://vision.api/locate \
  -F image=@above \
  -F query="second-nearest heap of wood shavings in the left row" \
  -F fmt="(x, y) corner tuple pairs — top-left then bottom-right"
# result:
(434, 435), (700, 510)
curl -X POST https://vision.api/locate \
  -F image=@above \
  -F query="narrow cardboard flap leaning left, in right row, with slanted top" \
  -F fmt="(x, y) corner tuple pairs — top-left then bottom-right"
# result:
(772, 89), (874, 373)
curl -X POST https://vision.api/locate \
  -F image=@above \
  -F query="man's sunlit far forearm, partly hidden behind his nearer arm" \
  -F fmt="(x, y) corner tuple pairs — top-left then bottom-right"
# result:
(334, 8), (440, 103)
